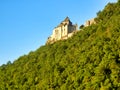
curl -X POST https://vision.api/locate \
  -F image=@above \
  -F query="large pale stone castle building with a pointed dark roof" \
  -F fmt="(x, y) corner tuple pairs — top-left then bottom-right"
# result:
(47, 17), (77, 43)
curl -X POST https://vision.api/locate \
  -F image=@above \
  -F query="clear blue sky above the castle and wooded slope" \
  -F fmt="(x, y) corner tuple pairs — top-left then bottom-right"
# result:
(0, 0), (116, 65)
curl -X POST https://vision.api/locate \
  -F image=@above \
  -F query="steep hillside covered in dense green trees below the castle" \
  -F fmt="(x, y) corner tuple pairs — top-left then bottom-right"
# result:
(0, 0), (120, 90)
